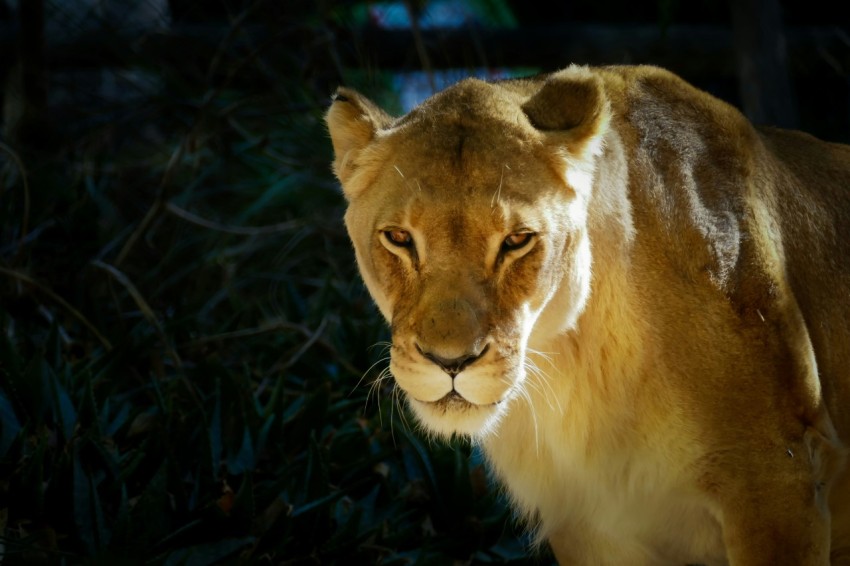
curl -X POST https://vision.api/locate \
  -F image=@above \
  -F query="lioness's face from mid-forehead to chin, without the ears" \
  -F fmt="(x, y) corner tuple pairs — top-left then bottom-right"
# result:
(346, 140), (589, 434)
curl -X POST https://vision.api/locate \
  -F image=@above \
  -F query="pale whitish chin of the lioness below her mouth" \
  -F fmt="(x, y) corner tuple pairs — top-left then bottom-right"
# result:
(408, 392), (503, 438)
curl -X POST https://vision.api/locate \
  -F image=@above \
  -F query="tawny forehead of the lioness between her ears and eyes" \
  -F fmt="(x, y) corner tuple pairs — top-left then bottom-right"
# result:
(362, 117), (571, 253)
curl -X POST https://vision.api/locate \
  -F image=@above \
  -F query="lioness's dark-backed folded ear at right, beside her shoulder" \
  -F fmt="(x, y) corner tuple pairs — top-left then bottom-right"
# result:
(522, 66), (611, 157)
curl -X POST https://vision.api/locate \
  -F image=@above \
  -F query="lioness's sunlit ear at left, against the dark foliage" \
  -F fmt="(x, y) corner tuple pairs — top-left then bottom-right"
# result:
(325, 87), (392, 196)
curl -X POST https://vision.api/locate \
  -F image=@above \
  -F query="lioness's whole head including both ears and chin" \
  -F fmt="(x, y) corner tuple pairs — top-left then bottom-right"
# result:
(327, 67), (609, 436)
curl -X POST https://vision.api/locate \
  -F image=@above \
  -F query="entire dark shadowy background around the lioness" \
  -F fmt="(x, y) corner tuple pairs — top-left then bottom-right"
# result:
(0, 0), (850, 564)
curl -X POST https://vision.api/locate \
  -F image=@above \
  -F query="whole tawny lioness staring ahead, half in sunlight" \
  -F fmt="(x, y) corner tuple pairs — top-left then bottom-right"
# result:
(327, 66), (850, 566)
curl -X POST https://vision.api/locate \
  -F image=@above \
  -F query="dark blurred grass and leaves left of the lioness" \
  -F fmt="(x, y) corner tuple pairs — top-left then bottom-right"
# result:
(0, 2), (545, 566)
